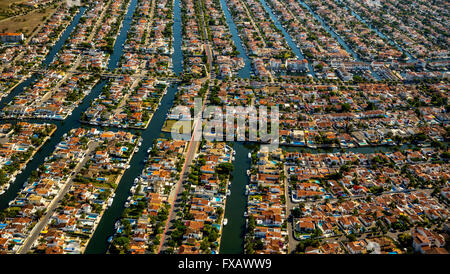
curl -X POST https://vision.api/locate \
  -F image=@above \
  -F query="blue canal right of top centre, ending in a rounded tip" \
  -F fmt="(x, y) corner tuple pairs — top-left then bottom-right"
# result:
(220, 0), (252, 79)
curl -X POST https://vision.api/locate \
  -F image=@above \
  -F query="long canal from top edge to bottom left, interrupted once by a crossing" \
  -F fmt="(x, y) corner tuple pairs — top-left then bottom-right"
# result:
(85, 0), (183, 254)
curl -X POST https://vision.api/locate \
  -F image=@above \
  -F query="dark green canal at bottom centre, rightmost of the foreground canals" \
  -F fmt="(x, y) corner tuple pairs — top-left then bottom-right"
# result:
(220, 142), (251, 254)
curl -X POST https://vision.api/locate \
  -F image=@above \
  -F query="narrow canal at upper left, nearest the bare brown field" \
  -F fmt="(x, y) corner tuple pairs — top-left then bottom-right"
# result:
(0, 7), (86, 108)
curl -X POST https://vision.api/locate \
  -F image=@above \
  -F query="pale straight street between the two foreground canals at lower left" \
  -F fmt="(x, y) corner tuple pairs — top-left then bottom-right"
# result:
(17, 142), (99, 254)
